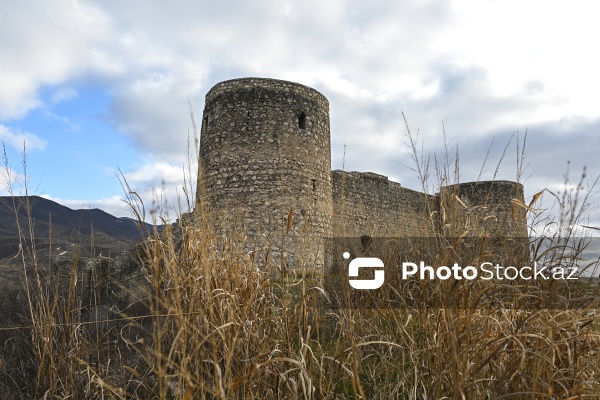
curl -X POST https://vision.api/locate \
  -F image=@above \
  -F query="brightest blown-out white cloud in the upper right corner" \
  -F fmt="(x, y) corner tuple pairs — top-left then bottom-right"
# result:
(440, 0), (600, 122)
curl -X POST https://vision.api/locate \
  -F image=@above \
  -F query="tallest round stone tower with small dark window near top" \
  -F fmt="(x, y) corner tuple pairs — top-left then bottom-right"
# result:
(197, 78), (332, 266)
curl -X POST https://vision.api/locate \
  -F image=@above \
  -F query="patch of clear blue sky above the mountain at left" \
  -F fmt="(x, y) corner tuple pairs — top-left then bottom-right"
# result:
(5, 85), (143, 200)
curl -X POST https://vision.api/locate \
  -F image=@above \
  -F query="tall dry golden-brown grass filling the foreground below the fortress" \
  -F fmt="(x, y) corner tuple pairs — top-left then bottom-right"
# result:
(0, 133), (600, 400)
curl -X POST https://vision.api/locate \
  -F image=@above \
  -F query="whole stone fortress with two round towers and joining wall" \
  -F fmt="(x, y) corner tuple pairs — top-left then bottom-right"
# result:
(195, 78), (527, 265)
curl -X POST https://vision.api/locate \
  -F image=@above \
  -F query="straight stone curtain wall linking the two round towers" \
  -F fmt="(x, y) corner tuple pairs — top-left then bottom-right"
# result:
(331, 170), (438, 237)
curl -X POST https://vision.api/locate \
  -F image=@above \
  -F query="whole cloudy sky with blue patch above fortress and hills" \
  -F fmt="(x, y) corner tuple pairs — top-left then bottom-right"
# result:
(0, 0), (600, 228)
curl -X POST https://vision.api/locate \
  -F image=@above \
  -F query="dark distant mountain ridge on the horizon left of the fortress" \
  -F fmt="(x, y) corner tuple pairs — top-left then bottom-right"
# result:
(0, 196), (157, 261)
